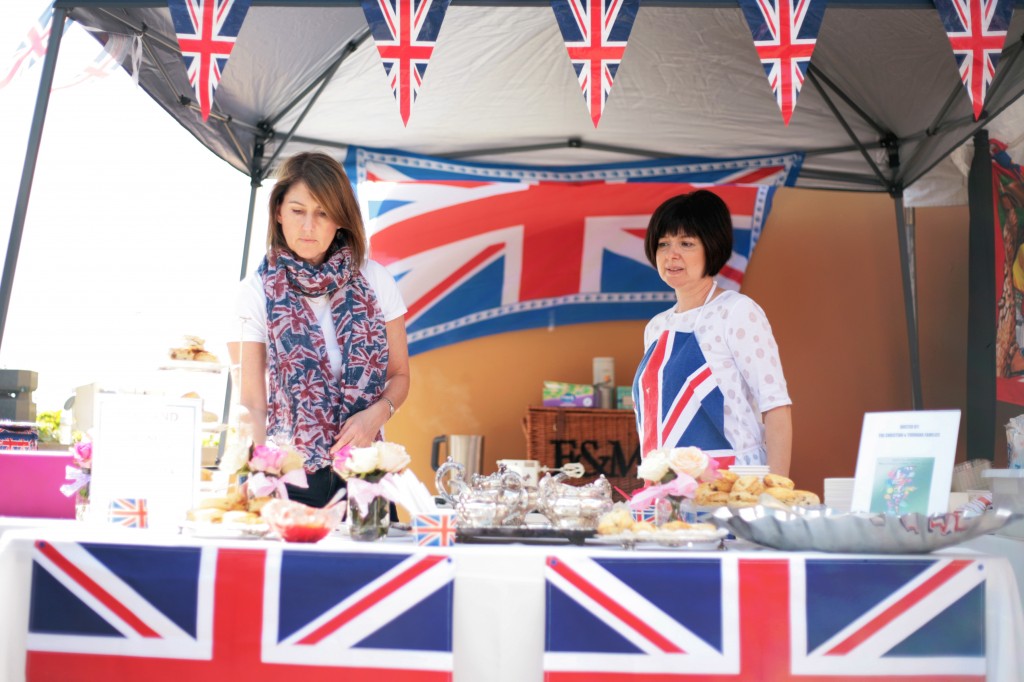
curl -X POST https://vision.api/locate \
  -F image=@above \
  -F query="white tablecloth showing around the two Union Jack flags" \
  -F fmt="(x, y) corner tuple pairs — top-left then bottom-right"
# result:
(0, 519), (1024, 682)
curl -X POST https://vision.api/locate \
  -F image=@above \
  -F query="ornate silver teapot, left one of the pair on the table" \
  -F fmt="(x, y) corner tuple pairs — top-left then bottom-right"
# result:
(434, 458), (529, 528)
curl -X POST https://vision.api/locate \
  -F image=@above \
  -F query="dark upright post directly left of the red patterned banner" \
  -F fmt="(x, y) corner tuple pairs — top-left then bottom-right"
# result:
(966, 130), (996, 460)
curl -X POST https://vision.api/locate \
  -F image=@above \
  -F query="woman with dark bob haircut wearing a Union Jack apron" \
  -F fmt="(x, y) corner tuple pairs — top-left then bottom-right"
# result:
(633, 189), (793, 476)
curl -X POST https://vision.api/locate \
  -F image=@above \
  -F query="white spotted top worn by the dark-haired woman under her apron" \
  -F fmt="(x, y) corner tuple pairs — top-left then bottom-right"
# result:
(643, 284), (793, 464)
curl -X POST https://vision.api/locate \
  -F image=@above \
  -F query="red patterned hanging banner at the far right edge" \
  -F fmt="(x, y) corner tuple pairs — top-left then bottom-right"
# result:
(989, 138), (1024, 406)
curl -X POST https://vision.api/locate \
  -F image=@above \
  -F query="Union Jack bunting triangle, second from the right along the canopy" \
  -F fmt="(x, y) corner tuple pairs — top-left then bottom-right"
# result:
(739, 0), (826, 125)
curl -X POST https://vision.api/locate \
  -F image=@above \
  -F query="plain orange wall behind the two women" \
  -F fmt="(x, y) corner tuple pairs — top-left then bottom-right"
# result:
(387, 188), (978, 493)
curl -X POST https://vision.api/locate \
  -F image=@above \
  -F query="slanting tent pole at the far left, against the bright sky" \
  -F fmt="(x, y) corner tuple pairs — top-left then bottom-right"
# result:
(0, 9), (68, 352)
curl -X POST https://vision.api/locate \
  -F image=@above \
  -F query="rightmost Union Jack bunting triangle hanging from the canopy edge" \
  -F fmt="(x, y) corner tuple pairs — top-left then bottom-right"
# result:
(935, 0), (1014, 121)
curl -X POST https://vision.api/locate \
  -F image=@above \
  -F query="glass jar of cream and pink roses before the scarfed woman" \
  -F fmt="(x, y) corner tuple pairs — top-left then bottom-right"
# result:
(334, 441), (412, 542)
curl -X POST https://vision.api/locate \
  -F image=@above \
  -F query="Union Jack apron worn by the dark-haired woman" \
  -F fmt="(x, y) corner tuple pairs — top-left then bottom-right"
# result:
(633, 286), (736, 467)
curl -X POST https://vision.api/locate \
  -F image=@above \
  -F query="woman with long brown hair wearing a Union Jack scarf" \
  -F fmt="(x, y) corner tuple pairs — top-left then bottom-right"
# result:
(228, 153), (410, 507)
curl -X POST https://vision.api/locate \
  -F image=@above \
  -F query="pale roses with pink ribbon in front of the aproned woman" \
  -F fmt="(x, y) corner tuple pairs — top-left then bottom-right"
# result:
(630, 447), (720, 525)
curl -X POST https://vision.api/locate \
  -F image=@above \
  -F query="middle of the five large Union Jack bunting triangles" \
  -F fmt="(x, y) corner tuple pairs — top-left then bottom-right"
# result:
(551, 0), (640, 128)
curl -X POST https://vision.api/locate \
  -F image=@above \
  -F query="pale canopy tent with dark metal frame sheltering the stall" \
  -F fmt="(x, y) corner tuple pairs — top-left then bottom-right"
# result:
(6, 0), (1024, 451)
